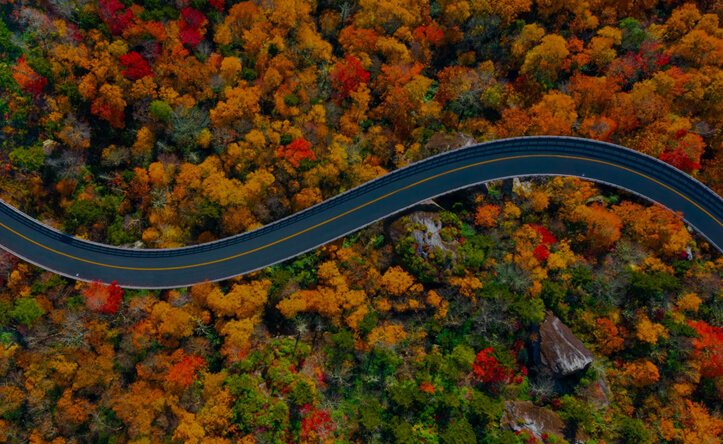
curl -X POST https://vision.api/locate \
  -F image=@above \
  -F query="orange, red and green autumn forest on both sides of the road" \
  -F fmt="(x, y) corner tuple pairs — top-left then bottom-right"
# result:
(0, 0), (723, 444)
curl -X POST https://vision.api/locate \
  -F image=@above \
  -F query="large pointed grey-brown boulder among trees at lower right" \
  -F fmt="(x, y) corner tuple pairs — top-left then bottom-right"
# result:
(540, 313), (593, 376)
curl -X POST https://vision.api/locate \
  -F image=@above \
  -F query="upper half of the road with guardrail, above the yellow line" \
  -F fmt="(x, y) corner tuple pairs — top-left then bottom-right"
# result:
(0, 137), (723, 258)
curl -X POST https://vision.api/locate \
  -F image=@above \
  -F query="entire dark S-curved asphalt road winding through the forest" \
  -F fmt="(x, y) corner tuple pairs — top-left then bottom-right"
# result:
(0, 137), (723, 289)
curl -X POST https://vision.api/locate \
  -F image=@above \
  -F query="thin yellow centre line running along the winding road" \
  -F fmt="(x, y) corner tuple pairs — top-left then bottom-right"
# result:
(0, 154), (723, 271)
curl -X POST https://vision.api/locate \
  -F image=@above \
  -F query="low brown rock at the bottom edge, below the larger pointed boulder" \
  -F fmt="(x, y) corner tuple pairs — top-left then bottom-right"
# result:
(502, 401), (565, 441)
